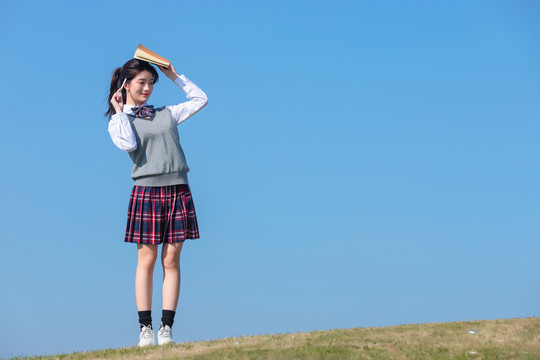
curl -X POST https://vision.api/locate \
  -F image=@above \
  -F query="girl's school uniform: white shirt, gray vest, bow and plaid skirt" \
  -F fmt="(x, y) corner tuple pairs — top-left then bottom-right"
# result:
(108, 75), (208, 244)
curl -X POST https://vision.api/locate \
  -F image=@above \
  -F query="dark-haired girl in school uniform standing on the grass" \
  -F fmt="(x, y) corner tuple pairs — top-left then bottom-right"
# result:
(105, 59), (208, 346)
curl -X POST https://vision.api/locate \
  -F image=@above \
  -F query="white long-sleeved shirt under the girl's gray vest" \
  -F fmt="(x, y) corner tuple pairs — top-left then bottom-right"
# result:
(109, 74), (208, 152)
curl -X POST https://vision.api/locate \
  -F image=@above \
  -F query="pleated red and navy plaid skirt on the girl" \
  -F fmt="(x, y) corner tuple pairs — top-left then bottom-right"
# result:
(124, 184), (199, 244)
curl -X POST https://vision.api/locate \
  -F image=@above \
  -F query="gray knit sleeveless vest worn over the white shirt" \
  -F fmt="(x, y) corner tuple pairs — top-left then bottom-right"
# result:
(128, 107), (189, 186)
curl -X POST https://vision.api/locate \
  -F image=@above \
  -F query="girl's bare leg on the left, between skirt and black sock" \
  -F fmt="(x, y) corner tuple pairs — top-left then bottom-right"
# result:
(135, 244), (157, 311)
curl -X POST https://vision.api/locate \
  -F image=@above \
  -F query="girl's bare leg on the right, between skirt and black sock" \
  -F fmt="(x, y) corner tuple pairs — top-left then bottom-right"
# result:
(161, 242), (184, 311)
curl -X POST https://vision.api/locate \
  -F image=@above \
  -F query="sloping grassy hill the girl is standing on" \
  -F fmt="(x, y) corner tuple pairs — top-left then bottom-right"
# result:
(14, 317), (540, 360)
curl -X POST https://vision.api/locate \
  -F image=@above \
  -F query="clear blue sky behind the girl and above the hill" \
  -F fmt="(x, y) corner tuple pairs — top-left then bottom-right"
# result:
(0, 0), (540, 357)
